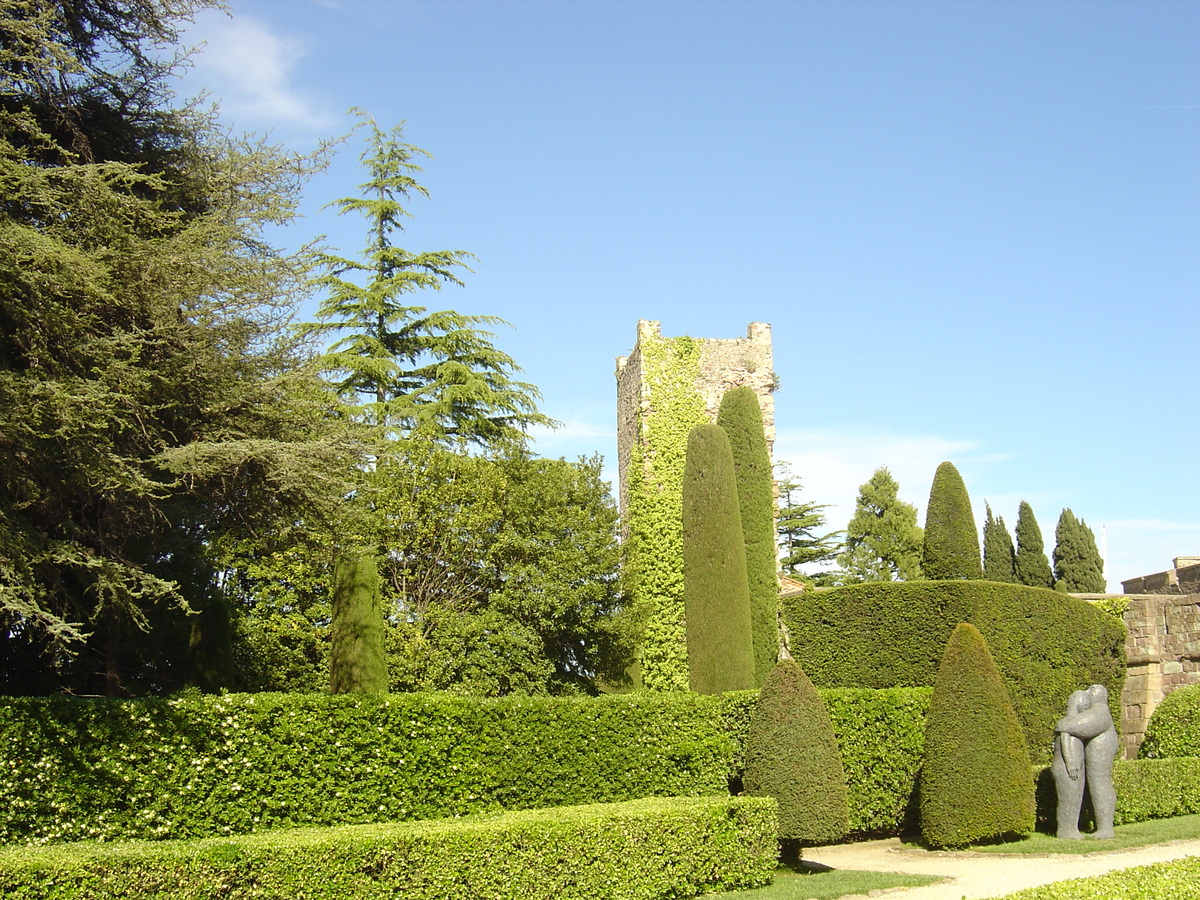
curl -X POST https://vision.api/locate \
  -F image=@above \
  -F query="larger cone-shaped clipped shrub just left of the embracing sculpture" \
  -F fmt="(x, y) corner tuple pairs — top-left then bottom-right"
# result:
(919, 623), (1034, 847)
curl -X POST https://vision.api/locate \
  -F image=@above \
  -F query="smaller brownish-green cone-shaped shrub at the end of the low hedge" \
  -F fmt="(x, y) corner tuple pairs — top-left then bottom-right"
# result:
(743, 660), (850, 860)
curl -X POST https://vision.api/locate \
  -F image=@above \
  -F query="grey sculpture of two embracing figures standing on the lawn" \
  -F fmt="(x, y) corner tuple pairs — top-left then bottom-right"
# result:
(1050, 684), (1120, 840)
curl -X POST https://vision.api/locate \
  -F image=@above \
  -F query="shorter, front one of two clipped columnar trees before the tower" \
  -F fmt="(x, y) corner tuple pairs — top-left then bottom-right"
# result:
(683, 425), (755, 694)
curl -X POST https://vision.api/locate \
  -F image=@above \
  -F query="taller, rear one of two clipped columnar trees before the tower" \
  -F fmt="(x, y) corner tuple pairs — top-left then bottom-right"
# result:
(716, 388), (779, 685)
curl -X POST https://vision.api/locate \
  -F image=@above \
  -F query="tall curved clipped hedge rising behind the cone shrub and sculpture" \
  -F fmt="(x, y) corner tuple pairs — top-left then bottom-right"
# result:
(784, 581), (1126, 762)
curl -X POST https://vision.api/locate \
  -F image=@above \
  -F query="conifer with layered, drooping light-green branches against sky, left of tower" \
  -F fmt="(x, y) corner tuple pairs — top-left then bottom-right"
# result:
(302, 110), (557, 446)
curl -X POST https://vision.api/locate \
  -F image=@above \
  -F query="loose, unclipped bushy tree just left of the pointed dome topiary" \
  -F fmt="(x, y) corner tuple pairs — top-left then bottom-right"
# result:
(838, 468), (922, 581)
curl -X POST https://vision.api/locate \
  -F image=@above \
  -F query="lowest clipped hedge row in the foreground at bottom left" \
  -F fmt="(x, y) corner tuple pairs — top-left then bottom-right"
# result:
(0, 797), (776, 900)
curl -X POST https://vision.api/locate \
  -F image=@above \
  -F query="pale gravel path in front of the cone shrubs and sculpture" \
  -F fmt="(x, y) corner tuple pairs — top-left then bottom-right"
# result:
(804, 838), (1200, 900)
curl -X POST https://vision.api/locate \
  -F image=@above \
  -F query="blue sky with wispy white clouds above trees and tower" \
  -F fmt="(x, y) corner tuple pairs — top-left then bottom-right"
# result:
(174, 0), (1200, 590)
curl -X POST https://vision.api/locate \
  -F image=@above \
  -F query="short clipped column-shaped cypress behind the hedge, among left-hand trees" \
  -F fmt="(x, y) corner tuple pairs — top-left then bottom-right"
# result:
(329, 552), (388, 694)
